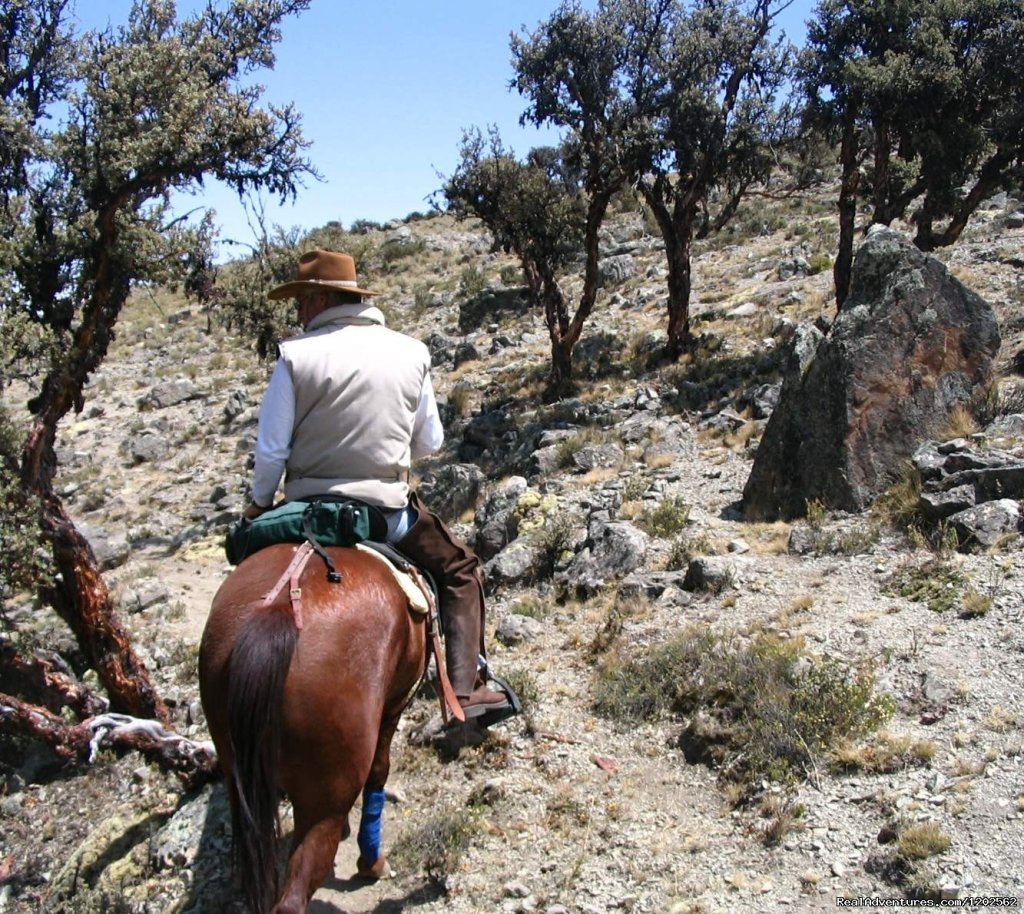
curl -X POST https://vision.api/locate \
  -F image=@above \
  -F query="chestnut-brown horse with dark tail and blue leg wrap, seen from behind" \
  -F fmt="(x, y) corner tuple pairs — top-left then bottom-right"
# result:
(199, 545), (427, 914)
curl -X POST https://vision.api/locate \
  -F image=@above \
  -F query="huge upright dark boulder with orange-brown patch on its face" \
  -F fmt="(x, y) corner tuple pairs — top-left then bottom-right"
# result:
(742, 226), (999, 519)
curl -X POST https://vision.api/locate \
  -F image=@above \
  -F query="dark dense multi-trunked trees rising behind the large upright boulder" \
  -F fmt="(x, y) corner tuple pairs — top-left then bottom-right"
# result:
(801, 0), (1024, 306)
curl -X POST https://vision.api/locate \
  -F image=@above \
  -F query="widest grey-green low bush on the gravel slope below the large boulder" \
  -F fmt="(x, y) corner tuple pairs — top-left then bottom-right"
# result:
(596, 626), (894, 784)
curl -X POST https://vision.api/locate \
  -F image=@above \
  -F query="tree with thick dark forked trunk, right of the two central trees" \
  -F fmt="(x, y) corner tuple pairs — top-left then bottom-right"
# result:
(624, 0), (792, 358)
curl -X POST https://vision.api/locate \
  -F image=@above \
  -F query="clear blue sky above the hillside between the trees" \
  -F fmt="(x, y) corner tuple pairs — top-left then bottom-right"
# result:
(75, 0), (811, 257)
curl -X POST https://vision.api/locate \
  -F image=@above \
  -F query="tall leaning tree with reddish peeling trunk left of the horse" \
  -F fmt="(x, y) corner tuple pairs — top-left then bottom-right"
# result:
(0, 0), (310, 757)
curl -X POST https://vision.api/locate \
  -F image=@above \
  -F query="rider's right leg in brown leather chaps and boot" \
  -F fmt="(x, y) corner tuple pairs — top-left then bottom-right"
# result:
(395, 493), (508, 716)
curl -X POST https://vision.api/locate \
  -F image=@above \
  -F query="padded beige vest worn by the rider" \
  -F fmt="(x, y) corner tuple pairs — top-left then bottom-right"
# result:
(280, 304), (430, 508)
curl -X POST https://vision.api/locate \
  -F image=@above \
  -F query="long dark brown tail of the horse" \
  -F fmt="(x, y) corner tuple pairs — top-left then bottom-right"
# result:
(227, 609), (299, 914)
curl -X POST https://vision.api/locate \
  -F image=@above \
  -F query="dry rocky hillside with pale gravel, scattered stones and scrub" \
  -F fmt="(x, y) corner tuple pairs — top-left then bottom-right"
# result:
(0, 187), (1024, 914)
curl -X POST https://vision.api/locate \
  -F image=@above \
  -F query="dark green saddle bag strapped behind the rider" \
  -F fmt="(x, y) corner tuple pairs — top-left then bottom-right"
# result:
(224, 497), (387, 565)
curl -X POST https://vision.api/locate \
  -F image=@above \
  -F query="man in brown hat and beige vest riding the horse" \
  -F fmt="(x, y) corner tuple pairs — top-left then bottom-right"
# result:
(244, 251), (518, 727)
